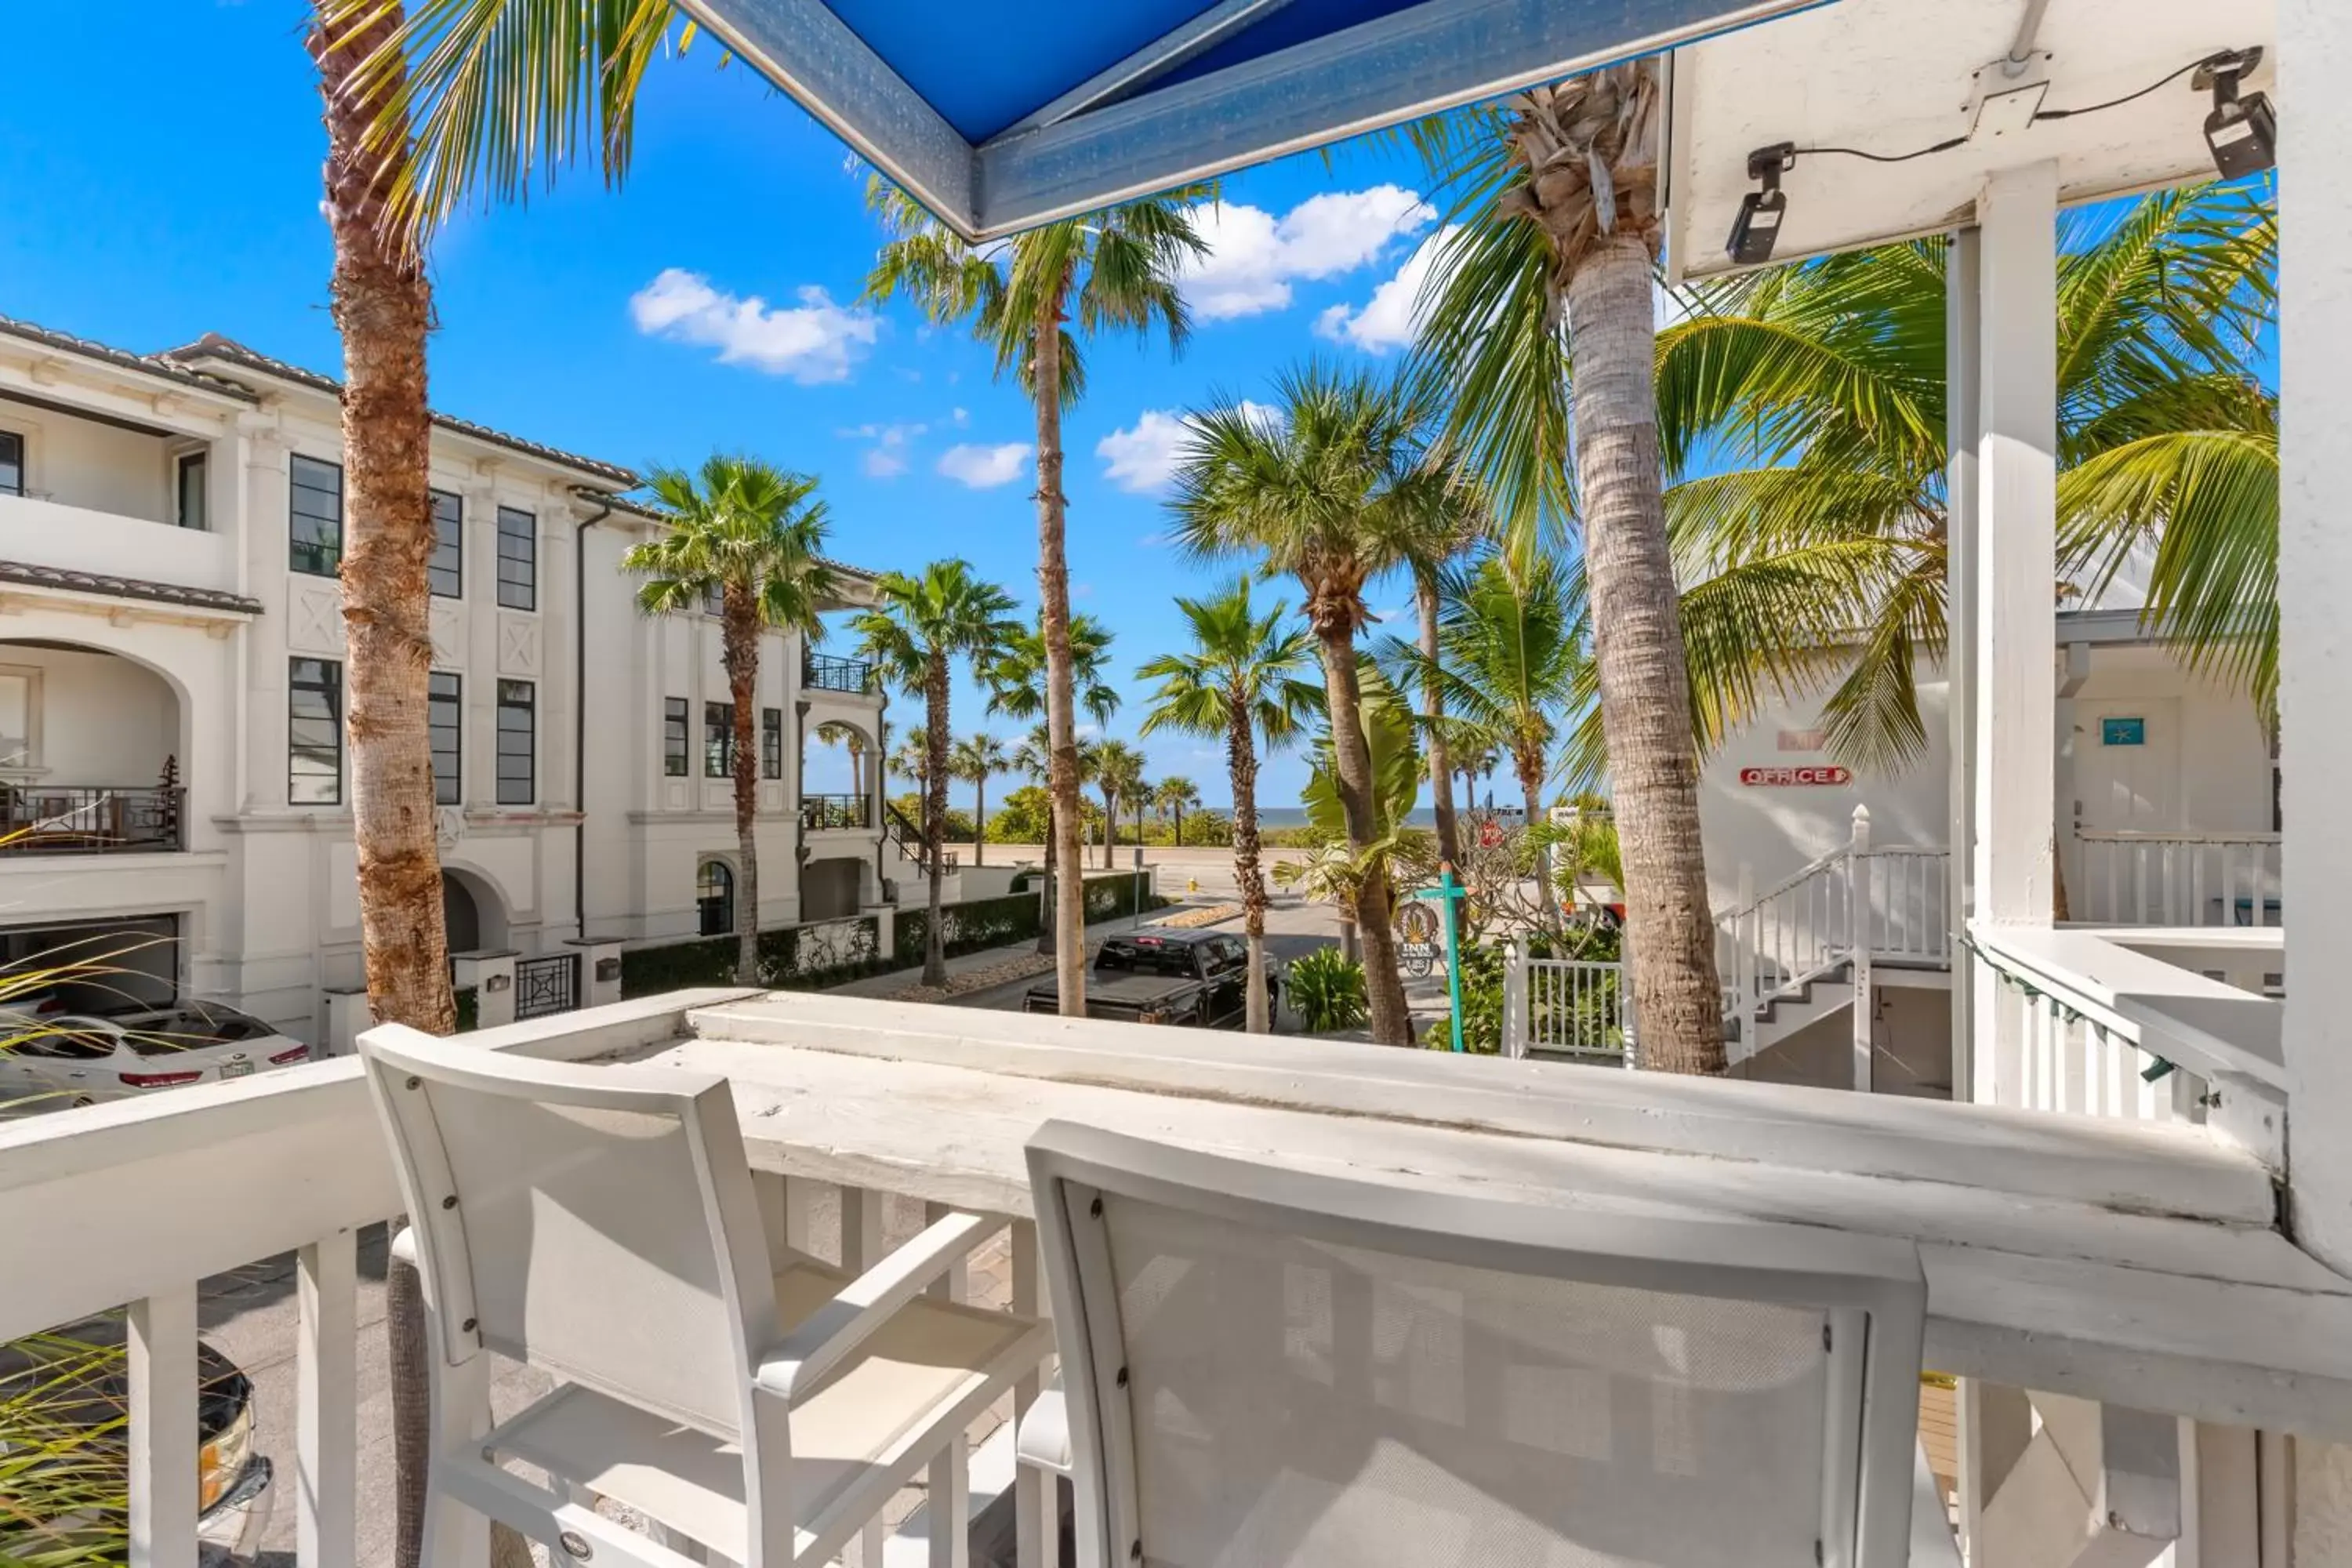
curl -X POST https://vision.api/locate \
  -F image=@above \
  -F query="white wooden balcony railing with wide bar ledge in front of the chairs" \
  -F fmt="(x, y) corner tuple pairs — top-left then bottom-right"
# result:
(0, 992), (2352, 1568)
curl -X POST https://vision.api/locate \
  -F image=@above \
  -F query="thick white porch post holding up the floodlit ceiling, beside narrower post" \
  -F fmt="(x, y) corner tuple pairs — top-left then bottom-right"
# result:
(1969, 162), (2058, 1100)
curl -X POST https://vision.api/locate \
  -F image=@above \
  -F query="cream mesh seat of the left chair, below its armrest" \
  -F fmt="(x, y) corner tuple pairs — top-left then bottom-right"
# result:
(485, 1260), (1044, 1563)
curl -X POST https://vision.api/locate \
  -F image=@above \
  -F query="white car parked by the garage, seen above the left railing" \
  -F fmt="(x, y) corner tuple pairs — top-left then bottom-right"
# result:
(0, 999), (310, 1114)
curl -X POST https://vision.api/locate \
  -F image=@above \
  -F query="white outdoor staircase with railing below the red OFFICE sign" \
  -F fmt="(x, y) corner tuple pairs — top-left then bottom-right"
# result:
(1715, 806), (1952, 1086)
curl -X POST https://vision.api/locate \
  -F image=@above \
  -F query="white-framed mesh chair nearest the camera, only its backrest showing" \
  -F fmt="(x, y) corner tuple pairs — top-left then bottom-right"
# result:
(1021, 1123), (1950, 1568)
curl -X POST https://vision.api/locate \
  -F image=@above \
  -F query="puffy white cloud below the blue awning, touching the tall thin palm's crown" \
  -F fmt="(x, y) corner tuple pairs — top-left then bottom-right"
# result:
(1181, 186), (1437, 322)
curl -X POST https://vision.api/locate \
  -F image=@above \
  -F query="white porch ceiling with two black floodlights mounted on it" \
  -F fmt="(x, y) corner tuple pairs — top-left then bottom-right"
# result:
(1668, 0), (2277, 280)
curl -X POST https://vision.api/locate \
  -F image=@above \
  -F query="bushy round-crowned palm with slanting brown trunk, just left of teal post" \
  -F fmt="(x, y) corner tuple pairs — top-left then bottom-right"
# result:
(1171, 365), (1444, 1046)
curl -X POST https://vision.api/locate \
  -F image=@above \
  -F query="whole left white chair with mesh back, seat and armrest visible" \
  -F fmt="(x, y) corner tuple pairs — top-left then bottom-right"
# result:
(360, 1027), (1049, 1568)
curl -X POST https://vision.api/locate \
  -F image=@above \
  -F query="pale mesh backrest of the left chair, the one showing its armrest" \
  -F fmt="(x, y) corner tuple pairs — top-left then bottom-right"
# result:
(360, 1025), (776, 1436)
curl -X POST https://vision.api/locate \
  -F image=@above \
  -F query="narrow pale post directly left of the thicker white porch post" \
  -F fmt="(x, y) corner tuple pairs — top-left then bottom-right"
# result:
(1943, 228), (1980, 1100)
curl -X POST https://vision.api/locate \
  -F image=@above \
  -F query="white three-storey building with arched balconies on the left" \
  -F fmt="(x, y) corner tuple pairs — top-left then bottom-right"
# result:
(0, 318), (908, 1039)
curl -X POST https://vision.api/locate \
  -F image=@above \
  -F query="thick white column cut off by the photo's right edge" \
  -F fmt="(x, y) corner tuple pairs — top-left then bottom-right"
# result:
(2279, 0), (2352, 1274)
